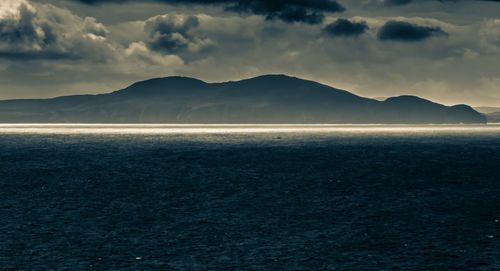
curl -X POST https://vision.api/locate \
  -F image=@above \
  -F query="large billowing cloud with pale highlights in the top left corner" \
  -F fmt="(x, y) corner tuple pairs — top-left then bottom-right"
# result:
(0, 0), (113, 61)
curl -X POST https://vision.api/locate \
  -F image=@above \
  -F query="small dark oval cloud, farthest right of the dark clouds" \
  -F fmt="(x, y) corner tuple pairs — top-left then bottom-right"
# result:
(378, 21), (448, 42)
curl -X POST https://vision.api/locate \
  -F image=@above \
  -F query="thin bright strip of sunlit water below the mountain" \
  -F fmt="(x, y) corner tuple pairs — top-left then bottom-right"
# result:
(0, 124), (500, 134)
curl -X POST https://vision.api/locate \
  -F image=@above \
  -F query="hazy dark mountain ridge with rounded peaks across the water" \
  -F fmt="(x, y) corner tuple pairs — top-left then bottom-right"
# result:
(0, 75), (486, 124)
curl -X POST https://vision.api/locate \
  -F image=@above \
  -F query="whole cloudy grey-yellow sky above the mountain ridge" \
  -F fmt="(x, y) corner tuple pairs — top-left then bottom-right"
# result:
(0, 0), (500, 106)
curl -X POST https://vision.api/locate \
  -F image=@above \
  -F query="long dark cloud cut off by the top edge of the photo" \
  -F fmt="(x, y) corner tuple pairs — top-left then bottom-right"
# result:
(74, 0), (345, 24)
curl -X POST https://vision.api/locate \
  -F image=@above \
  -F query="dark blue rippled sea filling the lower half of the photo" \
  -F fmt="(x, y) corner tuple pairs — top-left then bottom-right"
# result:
(0, 127), (500, 270)
